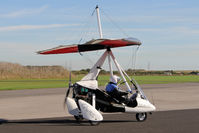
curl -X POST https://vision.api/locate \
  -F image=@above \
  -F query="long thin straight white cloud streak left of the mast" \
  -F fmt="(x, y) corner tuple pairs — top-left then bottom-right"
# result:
(0, 24), (79, 32)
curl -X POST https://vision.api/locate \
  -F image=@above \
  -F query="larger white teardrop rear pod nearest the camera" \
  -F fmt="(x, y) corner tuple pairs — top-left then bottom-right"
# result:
(78, 99), (103, 121)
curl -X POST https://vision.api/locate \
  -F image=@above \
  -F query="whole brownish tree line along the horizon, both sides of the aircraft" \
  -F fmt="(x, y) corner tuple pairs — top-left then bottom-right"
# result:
(0, 62), (199, 80)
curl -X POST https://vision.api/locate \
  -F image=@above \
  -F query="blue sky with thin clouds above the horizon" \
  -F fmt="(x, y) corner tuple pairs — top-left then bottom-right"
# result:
(0, 0), (199, 70)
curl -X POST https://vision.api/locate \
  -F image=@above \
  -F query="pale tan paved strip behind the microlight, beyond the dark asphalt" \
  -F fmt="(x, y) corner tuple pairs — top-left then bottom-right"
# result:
(0, 83), (199, 120)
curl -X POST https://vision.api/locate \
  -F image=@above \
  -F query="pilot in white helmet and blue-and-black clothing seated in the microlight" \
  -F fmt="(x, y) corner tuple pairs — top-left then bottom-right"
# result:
(106, 75), (128, 102)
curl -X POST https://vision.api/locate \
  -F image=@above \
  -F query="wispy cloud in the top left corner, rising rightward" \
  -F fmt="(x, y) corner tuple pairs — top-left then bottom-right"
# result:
(0, 5), (48, 18)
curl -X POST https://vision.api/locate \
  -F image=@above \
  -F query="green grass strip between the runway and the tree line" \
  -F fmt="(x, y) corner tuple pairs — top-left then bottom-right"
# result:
(0, 75), (199, 90)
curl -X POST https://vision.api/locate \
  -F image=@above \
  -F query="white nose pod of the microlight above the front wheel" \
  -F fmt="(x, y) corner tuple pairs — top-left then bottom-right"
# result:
(125, 97), (156, 113)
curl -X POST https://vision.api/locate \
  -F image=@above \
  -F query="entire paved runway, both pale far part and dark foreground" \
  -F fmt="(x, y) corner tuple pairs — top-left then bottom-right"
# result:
(0, 83), (199, 133)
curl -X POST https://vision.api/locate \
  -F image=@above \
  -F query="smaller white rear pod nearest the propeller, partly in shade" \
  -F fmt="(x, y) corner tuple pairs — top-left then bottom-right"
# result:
(66, 97), (80, 116)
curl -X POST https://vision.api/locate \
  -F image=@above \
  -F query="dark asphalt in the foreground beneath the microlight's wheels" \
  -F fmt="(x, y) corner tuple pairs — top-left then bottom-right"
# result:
(0, 109), (199, 133)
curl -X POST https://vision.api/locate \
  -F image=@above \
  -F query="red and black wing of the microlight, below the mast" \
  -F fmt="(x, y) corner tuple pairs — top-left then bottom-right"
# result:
(37, 38), (141, 54)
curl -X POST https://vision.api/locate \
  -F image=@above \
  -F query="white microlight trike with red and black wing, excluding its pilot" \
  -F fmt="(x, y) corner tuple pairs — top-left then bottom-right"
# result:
(38, 6), (156, 125)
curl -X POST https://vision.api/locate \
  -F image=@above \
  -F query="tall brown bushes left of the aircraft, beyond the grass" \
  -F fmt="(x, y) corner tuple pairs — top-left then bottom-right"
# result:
(0, 62), (69, 80)
